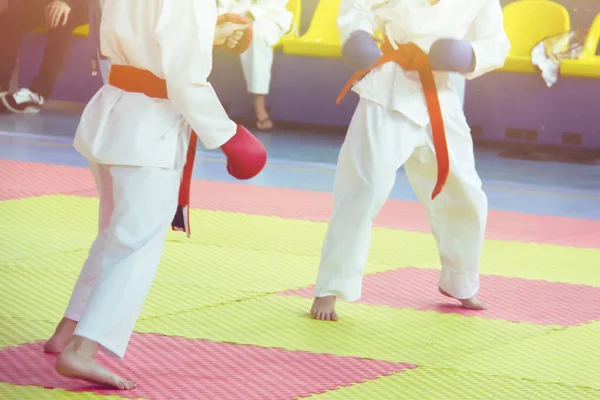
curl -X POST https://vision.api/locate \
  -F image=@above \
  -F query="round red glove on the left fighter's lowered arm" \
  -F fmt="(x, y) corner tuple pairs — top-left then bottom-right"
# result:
(221, 125), (267, 180)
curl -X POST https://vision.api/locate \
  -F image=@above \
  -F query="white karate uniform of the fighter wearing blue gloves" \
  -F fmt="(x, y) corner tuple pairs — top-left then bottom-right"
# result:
(315, 0), (510, 301)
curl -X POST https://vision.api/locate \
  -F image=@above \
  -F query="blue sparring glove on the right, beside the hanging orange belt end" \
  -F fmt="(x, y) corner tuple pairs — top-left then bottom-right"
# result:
(429, 39), (475, 73)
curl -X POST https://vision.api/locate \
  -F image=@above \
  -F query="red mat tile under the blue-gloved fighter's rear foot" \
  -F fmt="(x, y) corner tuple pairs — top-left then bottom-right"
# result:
(282, 268), (600, 326)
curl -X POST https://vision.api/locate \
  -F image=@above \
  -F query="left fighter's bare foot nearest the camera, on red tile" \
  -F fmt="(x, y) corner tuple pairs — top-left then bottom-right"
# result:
(55, 336), (137, 390)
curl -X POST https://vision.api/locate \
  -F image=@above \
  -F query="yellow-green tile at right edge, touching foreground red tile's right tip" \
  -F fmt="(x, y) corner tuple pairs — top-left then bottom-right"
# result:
(428, 328), (600, 390)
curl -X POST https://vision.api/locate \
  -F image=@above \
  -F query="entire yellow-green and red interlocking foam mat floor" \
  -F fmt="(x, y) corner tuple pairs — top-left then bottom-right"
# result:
(0, 161), (600, 400)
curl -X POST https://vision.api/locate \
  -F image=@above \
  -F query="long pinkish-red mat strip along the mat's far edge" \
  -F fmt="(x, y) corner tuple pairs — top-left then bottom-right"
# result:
(0, 160), (600, 248)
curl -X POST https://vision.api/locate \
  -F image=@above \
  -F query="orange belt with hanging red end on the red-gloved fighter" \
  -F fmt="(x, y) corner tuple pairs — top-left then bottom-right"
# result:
(108, 65), (198, 237)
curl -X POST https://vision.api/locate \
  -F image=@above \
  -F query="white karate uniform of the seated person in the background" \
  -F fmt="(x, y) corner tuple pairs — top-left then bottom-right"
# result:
(219, 0), (293, 95)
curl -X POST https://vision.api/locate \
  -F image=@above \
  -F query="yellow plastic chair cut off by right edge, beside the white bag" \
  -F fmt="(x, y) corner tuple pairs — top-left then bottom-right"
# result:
(560, 14), (600, 78)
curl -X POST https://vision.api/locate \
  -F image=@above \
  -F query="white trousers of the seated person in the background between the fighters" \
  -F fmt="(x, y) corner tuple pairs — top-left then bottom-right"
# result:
(240, 18), (283, 95)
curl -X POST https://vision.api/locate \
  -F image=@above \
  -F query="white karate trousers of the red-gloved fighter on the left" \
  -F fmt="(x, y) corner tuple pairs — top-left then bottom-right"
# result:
(65, 162), (182, 358)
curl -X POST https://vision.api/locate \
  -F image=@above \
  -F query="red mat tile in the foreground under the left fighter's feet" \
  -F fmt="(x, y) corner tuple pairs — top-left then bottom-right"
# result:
(0, 334), (416, 400)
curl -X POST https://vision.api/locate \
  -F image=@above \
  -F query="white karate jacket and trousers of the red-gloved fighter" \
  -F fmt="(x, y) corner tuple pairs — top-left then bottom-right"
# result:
(65, 0), (236, 358)
